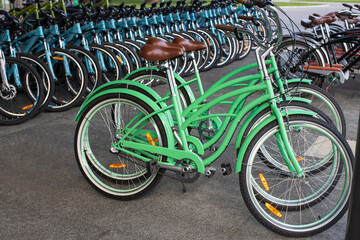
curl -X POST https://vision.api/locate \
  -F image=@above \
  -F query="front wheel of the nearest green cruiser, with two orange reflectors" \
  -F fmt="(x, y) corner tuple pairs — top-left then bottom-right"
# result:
(239, 115), (353, 237)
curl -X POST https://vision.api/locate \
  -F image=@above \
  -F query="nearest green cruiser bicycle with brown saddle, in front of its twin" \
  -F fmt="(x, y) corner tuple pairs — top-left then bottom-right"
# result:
(75, 0), (353, 236)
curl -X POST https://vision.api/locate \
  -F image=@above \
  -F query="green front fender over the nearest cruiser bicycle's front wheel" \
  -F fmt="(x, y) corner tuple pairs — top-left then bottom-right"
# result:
(234, 110), (316, 173)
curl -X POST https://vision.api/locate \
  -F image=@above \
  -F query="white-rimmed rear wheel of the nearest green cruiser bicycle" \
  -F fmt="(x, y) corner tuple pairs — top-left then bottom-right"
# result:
(75, 94), (167, 200)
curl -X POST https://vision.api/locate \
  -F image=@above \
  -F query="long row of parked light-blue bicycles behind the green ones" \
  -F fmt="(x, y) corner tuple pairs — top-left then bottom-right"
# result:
(0, 0), (258, 124)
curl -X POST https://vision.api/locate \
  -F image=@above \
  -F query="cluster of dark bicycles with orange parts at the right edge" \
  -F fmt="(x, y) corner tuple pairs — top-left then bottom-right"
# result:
(276, 3), (360, 87)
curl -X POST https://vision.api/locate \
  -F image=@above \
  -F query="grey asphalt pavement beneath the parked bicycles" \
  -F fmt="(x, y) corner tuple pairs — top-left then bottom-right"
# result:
(0, 2), (360, 240)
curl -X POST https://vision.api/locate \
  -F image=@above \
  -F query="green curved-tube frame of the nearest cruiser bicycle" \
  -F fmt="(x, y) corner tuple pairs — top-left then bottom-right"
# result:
(76, 44), (313, 176)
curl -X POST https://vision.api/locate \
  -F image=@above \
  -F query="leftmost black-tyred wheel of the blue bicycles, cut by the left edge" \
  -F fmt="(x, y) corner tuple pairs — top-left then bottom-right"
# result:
(0, 57), (45, 125)
